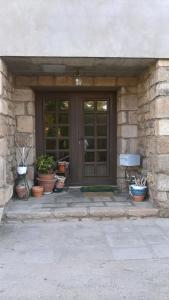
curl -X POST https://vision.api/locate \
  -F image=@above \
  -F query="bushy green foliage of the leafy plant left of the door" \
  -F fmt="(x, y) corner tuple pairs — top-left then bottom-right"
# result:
(36, 155), (56, 174)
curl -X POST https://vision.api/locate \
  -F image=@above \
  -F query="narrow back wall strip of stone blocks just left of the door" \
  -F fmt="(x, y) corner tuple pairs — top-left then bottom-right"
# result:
(13, 88), (35, 184)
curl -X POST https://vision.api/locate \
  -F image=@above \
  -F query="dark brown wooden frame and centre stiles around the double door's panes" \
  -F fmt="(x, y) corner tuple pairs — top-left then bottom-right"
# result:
(35, 91), (117, 185)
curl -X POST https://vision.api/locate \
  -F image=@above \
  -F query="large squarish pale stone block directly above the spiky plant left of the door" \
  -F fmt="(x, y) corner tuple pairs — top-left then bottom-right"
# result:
(17, 116), (34, 133)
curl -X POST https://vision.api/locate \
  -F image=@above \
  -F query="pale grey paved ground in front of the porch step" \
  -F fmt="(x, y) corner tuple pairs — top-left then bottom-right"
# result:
(0, 218), (169, 300)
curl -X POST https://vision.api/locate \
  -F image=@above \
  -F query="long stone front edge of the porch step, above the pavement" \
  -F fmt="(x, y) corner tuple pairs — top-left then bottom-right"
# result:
(3, 207), (159, 222)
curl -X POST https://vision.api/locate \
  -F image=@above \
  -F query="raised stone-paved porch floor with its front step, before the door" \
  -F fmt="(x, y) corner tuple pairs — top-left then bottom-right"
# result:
(4, 188), (158, 221)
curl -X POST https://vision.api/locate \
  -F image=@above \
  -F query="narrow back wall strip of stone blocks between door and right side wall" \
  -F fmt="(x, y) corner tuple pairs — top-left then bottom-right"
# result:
(117, 81), (138, 190)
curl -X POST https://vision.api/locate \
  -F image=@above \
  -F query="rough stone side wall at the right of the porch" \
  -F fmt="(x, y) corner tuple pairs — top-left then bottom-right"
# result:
(138, 60), (169, 208)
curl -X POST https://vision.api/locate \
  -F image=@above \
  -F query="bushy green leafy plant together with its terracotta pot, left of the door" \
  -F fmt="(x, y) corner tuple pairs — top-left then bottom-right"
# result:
(36, 155), (56, 194)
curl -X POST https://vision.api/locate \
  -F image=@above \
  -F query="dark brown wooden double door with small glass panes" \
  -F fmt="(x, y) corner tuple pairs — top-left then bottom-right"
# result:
(36, 92), (116, 185)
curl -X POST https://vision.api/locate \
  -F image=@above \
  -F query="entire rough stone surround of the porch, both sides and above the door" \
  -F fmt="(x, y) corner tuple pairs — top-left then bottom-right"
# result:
(0, 59), (169, 214)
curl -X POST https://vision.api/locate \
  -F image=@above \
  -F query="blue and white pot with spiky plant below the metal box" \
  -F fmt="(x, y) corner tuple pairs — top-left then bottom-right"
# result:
(129, 176), (147, 202)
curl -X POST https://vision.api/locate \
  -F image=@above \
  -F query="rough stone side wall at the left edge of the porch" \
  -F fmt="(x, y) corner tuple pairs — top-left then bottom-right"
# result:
(0, 60), (15, 185)
